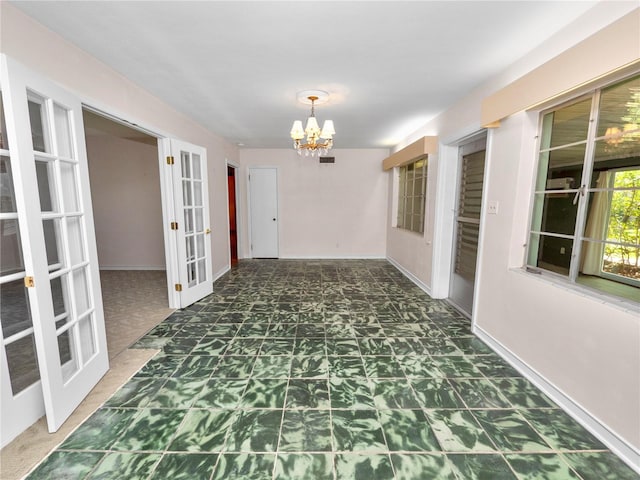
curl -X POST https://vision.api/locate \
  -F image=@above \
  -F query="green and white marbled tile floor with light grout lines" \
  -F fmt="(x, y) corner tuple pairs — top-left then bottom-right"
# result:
(27, 260), (640, 480)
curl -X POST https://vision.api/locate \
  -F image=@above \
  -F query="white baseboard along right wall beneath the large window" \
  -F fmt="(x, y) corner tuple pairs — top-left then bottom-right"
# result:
(473, 325), (640, 473)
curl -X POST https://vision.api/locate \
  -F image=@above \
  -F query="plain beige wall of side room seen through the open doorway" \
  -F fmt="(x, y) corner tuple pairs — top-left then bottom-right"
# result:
(86, 135), (165, 270)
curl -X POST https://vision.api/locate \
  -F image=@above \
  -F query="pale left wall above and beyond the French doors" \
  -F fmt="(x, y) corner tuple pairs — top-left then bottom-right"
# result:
(0, 2), (238, 282)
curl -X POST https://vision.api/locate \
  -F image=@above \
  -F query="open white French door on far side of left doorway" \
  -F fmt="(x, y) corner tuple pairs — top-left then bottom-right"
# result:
(168, 139), (213, 308)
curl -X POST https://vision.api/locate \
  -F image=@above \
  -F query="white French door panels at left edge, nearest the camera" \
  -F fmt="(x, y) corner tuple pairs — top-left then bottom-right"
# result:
(0, 55), (109, 445)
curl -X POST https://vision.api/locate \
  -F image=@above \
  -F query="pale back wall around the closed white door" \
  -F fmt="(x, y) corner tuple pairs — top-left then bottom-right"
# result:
(240, 149), (389, 258)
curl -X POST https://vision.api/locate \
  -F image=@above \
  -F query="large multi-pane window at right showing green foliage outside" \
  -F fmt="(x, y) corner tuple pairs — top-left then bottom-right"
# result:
(527, 75), (640, 302)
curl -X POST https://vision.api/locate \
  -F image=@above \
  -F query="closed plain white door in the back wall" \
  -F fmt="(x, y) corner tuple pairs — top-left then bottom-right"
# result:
(249, 168), (278, 258)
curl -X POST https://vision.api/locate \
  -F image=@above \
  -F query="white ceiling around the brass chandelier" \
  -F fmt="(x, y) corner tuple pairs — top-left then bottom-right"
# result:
(11, 1), (597, 148)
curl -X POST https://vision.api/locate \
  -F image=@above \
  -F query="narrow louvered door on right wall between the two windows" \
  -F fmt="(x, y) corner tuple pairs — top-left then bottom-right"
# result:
(449, 138), (486, 315)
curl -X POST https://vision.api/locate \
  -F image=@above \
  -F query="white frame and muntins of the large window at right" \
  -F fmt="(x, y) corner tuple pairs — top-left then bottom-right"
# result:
(523, 71), (640, 308)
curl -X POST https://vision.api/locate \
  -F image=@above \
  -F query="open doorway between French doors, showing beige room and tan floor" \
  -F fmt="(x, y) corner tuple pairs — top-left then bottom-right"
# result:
(83, 109), (173, 358)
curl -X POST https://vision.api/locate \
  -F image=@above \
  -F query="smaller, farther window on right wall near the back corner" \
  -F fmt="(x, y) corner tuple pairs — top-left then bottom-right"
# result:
(396, 156), (427, 233)
